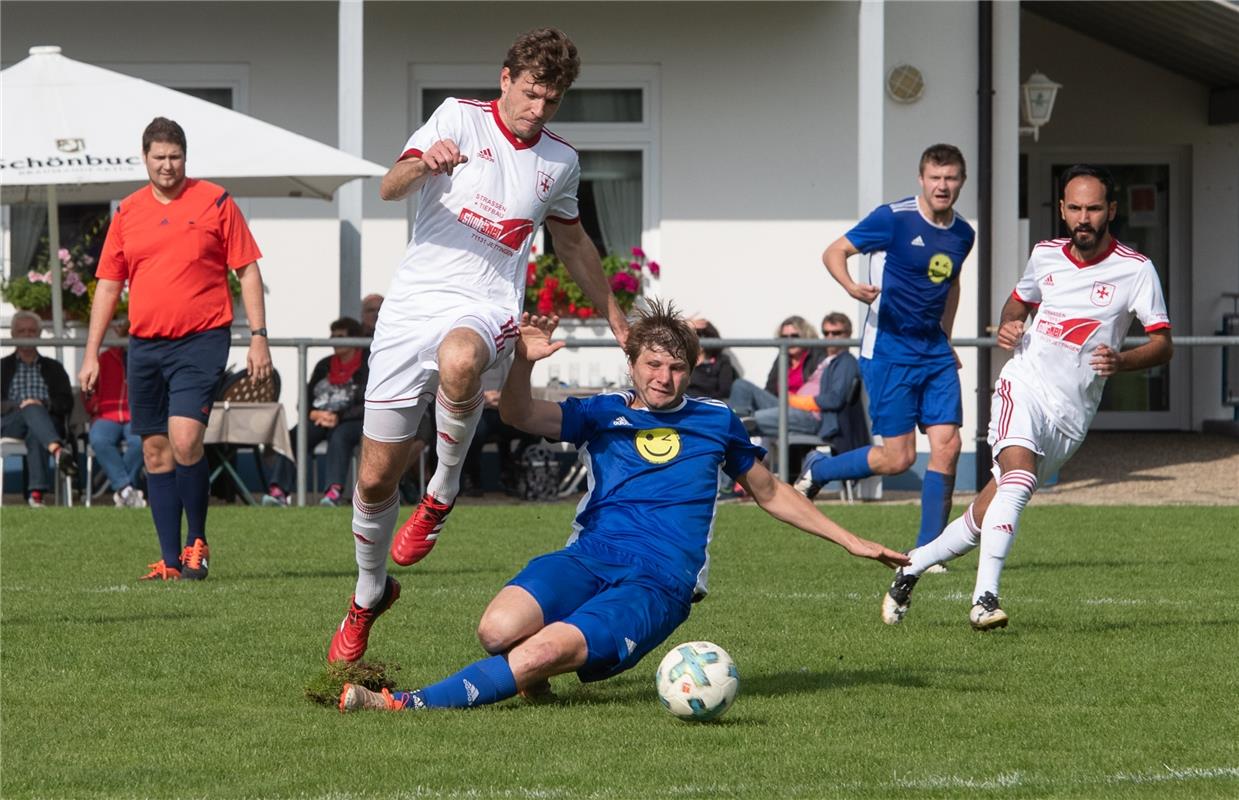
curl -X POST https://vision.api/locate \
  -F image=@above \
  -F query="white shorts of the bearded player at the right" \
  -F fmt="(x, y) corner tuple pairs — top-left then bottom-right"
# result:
(989, 378), (1084, 484)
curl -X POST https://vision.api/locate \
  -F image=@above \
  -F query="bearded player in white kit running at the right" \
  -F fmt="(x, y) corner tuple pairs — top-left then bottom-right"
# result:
(882, 165), (1173, 630)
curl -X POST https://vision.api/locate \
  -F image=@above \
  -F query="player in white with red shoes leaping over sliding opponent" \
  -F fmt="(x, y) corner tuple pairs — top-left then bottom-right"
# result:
(327, 27), (627, 661)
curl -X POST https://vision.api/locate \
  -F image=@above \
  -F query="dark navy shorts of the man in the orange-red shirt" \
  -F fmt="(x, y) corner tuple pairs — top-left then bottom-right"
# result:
(128, 328), (232, 436)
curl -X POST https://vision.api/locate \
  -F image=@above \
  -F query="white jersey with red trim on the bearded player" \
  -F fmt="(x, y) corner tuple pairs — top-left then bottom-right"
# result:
(1002, 239), (1170, 440)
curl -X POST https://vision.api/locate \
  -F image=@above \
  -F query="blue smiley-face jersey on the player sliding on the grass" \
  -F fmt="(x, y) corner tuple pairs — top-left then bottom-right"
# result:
(560, 391), (766, 594)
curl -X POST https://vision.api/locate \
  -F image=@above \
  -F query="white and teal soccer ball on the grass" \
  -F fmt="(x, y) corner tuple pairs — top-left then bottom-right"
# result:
(654, 641), (740, 722)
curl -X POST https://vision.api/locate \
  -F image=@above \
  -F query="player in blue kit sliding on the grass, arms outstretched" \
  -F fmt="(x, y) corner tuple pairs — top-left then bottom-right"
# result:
(339, 302), (908, 711)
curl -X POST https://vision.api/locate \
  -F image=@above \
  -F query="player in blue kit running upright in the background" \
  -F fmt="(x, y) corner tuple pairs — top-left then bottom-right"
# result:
(795, 145), (976, 557)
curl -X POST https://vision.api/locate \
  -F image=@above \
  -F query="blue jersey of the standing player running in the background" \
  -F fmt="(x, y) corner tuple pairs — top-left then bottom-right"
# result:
(846, 197), (976, 364)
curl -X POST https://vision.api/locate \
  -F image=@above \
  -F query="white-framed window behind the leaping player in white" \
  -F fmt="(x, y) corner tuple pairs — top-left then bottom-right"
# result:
(410, 64), (659, 261)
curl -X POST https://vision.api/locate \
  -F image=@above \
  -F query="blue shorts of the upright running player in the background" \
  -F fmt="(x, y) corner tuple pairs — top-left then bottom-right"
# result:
(860, 358), (964, 436)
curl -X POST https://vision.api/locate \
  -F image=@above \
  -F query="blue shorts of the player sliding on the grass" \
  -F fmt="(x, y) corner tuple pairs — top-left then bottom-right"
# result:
(508, 547), (691, 682)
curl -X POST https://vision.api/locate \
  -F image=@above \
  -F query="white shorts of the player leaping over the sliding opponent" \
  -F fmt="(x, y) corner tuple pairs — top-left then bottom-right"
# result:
(363, 303), (519, 441)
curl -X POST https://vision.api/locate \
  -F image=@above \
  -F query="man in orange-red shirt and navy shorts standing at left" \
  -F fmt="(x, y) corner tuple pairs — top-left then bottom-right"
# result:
(78, 116), (271, 581)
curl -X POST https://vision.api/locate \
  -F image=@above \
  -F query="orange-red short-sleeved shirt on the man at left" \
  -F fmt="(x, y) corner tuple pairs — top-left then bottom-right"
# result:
(95, 178), (263, 338)
